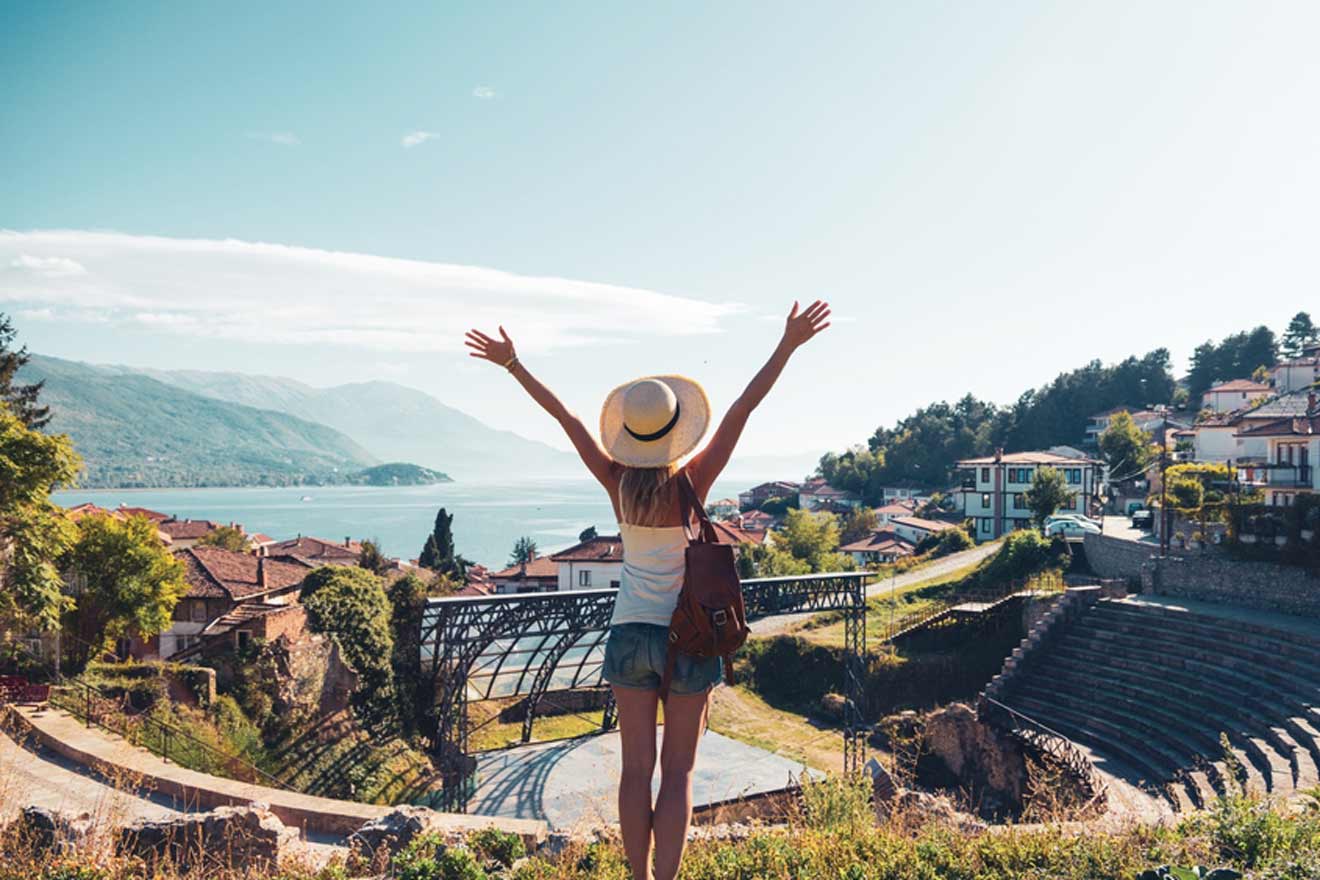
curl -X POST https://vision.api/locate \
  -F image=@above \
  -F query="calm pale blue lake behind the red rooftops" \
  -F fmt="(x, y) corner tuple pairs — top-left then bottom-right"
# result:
(54, 478), (774, 569)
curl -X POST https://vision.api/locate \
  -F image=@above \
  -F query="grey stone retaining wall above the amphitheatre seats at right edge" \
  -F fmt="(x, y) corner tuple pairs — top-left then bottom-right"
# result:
(1142, 555), (1320, 616)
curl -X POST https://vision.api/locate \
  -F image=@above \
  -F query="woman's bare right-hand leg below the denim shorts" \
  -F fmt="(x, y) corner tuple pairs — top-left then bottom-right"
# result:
(652, 691), (710, 880)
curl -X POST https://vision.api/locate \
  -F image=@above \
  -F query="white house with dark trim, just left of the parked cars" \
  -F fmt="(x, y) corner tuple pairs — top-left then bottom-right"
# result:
(958, 451), (1102, 541)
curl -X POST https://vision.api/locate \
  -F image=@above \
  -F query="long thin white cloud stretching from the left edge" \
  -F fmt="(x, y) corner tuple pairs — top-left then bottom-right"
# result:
(0, 230), (744, 354)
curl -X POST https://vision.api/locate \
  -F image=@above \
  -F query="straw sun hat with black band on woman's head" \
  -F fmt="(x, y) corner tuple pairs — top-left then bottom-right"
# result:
(601, 376), (710, 467)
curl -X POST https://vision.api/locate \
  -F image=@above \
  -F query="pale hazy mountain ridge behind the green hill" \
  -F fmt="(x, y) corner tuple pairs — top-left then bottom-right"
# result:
(132, 368), (582, 480)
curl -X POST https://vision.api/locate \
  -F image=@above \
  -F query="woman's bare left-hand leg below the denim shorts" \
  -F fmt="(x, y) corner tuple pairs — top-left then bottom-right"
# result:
(614, 687), (660, 880)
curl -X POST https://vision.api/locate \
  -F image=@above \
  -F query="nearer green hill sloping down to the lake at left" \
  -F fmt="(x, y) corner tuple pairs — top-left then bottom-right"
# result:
(20, 355), (380, 488)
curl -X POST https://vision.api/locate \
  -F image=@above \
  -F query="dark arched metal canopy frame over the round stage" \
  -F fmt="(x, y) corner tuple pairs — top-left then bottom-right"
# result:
(420, 571), (873, 811)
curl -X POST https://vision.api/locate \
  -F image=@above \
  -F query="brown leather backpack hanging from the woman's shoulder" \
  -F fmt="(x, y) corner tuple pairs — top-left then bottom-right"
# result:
(660, 471), (751, 699)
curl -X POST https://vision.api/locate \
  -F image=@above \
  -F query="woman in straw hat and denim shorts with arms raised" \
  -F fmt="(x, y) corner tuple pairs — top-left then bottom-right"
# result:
(466, 301), (829, 880)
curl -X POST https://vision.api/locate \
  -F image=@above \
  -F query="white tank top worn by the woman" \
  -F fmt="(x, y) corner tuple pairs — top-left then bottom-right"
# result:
(610, 522), (688, 627)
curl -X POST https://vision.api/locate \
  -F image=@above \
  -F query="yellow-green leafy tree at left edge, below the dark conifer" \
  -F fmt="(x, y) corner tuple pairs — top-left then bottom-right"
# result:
(0, 401), (82, 631)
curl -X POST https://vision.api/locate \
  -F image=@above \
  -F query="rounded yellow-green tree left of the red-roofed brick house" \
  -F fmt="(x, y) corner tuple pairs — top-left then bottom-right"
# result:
(61, 515), (187, 669)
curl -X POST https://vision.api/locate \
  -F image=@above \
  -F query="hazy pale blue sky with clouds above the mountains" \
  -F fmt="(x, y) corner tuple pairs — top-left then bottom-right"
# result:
(0, 6), (1320, 453)
